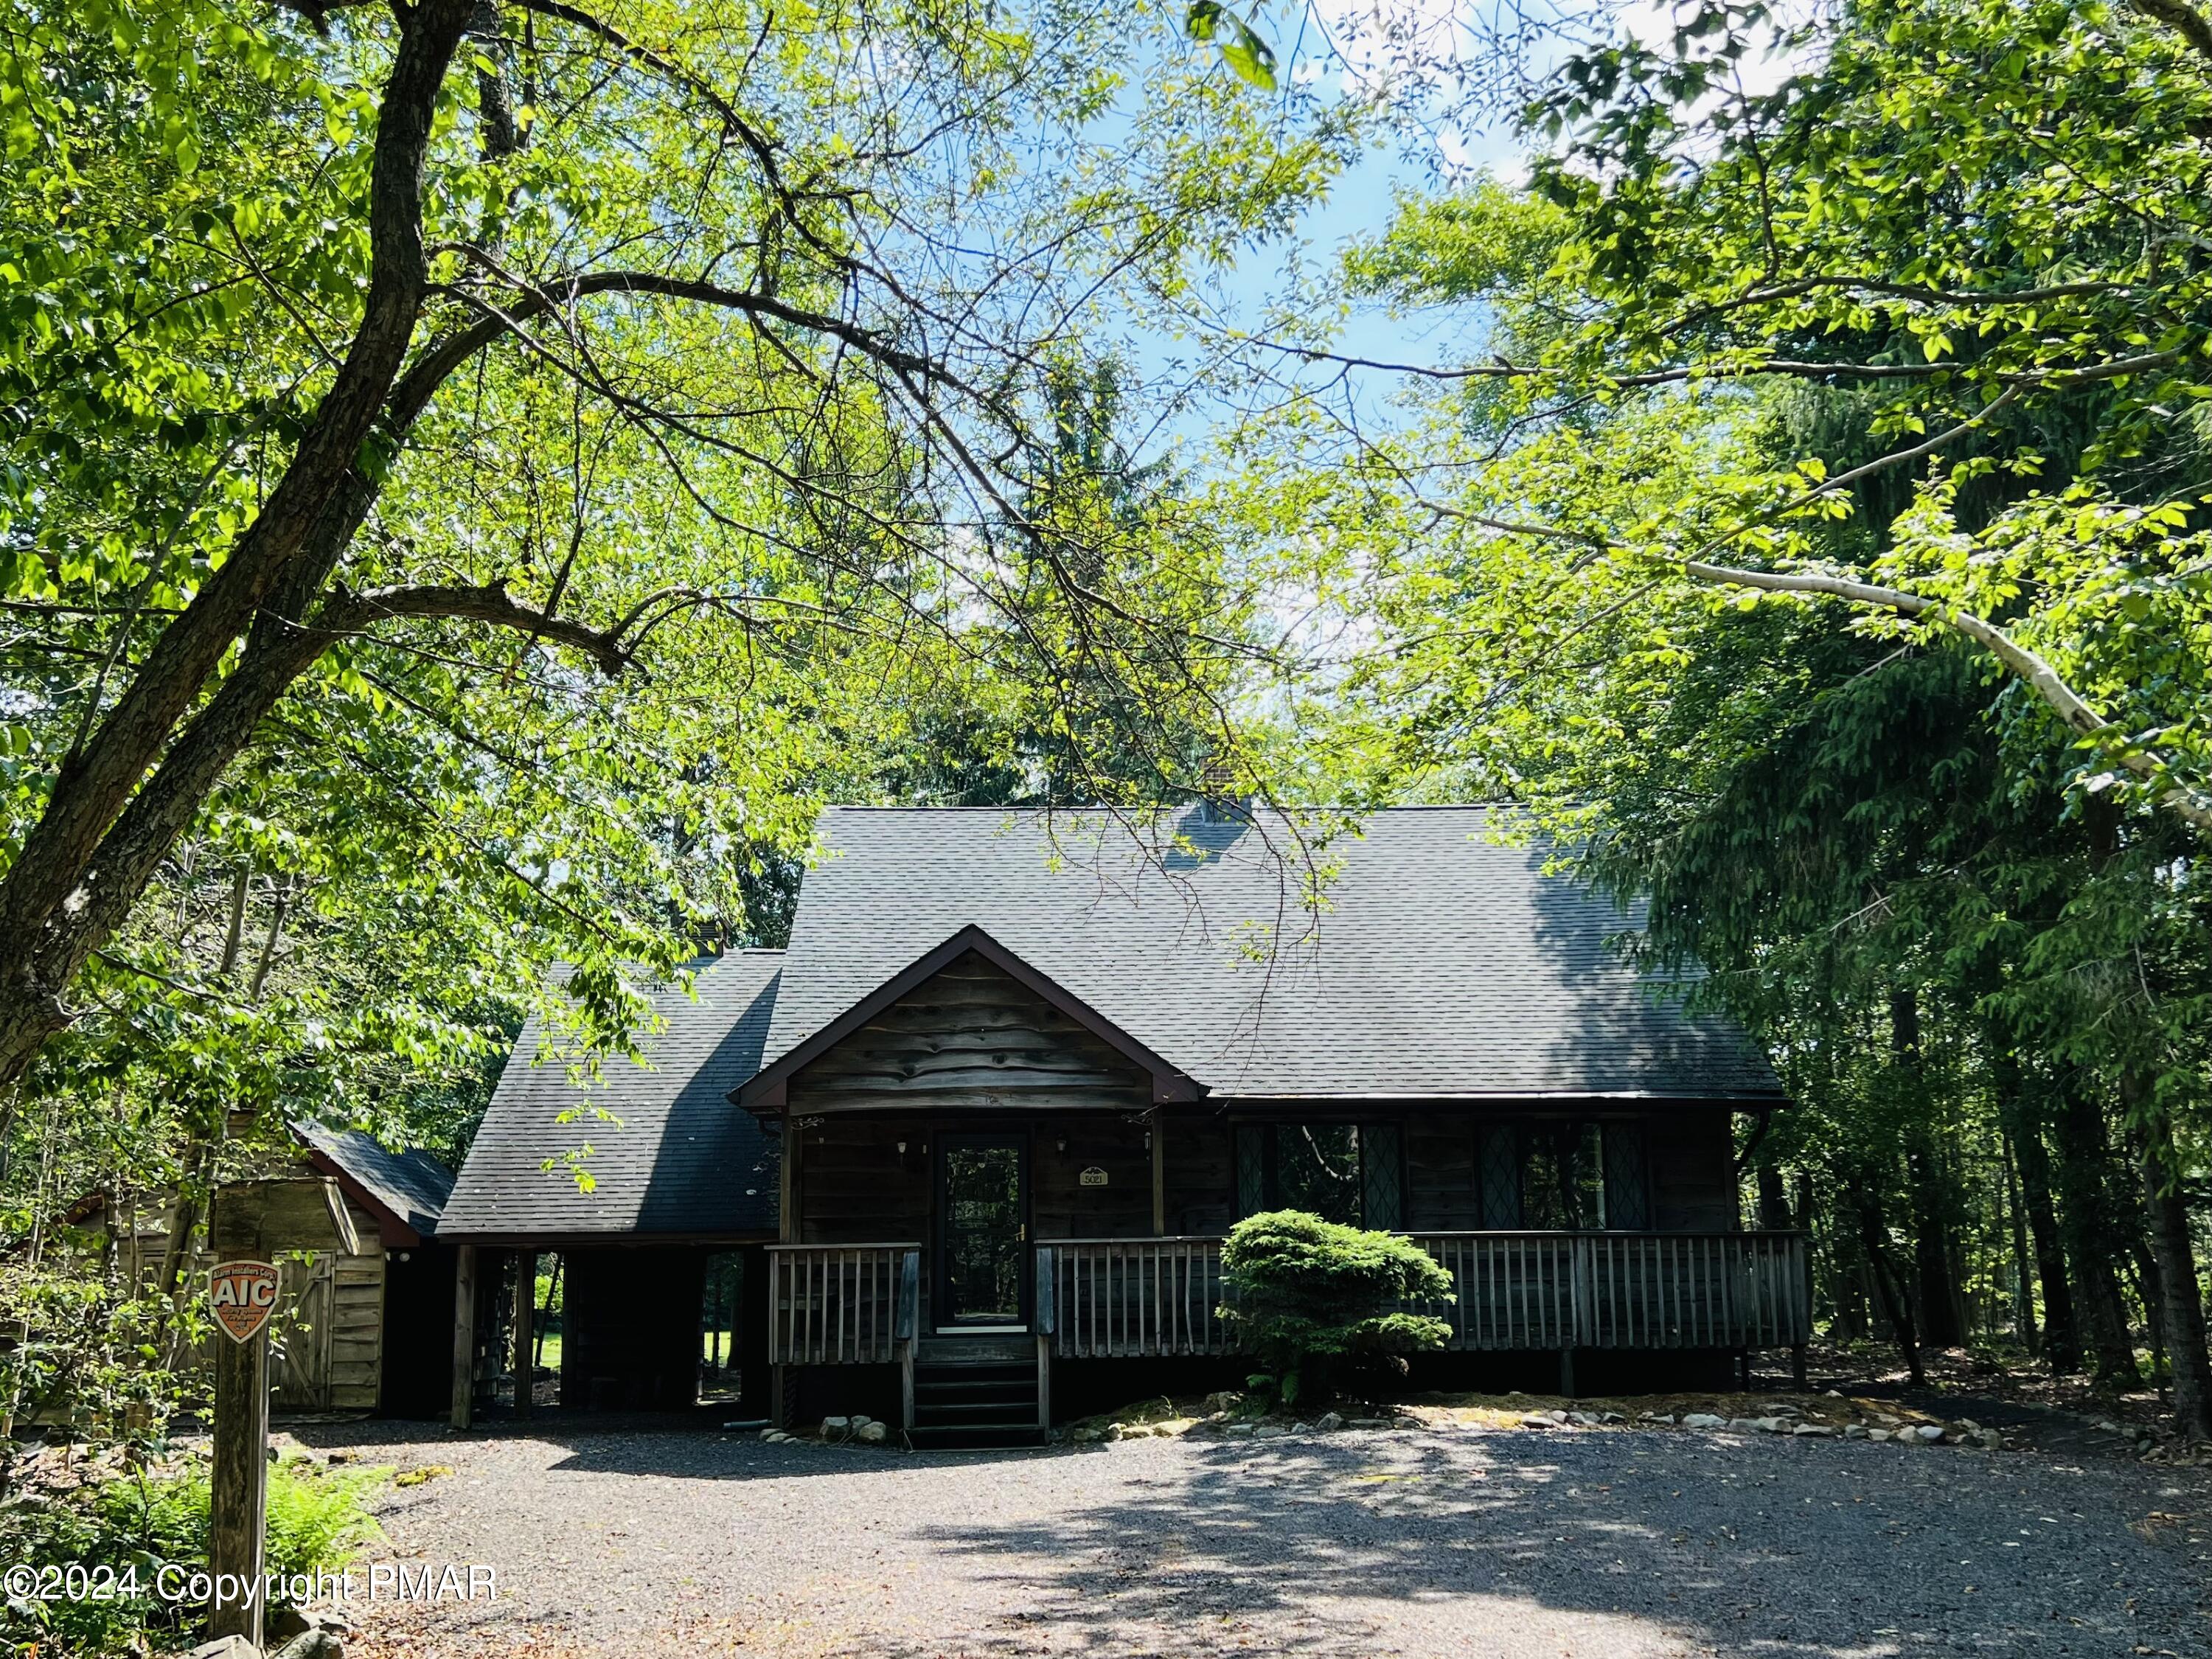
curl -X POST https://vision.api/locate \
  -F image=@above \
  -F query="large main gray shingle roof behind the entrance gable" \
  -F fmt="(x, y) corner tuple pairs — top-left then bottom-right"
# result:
(763, 807), (1781, 1099)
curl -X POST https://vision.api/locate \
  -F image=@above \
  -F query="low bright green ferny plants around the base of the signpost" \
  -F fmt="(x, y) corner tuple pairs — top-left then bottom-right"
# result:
(0, 1460), (392, 1659)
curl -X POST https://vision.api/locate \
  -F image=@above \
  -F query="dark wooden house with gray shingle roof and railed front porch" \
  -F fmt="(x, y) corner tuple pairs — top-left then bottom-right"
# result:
(442, 807), (1807, 1438)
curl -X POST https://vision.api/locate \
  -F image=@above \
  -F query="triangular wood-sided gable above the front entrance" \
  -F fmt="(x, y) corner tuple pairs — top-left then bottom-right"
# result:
(787, 953), (1152, 1117)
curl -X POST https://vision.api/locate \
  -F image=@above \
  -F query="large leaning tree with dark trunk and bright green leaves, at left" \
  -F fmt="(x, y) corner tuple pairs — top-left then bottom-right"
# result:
(0, 0), (1345, 1084)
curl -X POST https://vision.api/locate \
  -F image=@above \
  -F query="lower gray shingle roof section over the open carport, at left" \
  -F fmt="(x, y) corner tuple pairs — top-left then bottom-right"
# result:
(440, 951), (783, 1239)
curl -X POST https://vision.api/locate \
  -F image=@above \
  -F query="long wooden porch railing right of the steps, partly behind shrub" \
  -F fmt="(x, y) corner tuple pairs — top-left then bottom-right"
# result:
(1035, 1232), (1812, 1358)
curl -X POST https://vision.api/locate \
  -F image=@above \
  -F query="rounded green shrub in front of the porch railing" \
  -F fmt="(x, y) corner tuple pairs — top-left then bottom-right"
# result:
(1221, 1210), (1453, 1405)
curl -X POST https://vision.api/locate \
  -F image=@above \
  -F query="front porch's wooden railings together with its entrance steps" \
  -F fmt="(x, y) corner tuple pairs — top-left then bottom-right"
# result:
(768, 1230), (1812, 1436)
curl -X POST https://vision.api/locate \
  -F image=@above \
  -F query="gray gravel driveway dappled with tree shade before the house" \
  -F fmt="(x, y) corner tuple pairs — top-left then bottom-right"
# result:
(305, 1425), (2212, 1659)
